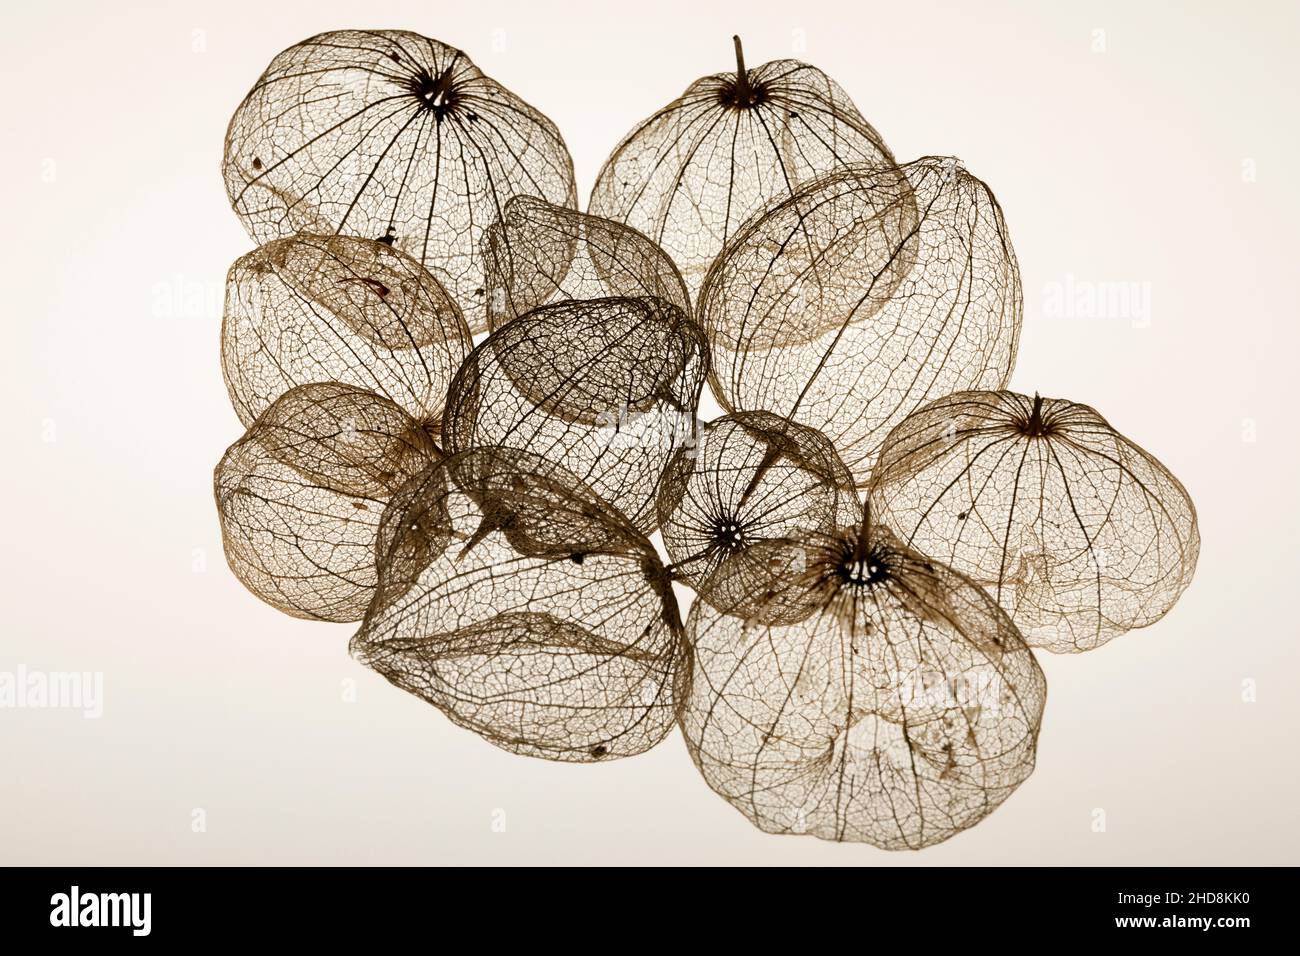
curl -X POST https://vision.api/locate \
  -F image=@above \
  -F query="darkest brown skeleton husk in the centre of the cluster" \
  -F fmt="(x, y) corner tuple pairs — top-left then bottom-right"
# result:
(442, 298), (709, 533)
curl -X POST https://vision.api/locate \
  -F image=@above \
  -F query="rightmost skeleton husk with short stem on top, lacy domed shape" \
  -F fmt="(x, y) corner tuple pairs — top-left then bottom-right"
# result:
(870, 392), (1200, 652)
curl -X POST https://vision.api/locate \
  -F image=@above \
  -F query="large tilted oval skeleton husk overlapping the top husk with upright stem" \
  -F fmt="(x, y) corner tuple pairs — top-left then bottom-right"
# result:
(697, 157), (1022, 486)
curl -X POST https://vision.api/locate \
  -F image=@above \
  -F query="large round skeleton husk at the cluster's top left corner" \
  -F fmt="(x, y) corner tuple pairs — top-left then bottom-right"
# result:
(224, 30), (577, 332)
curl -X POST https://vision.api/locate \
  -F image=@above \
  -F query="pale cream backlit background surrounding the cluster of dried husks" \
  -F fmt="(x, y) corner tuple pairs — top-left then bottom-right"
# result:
(0, 0), (1300, 866)
